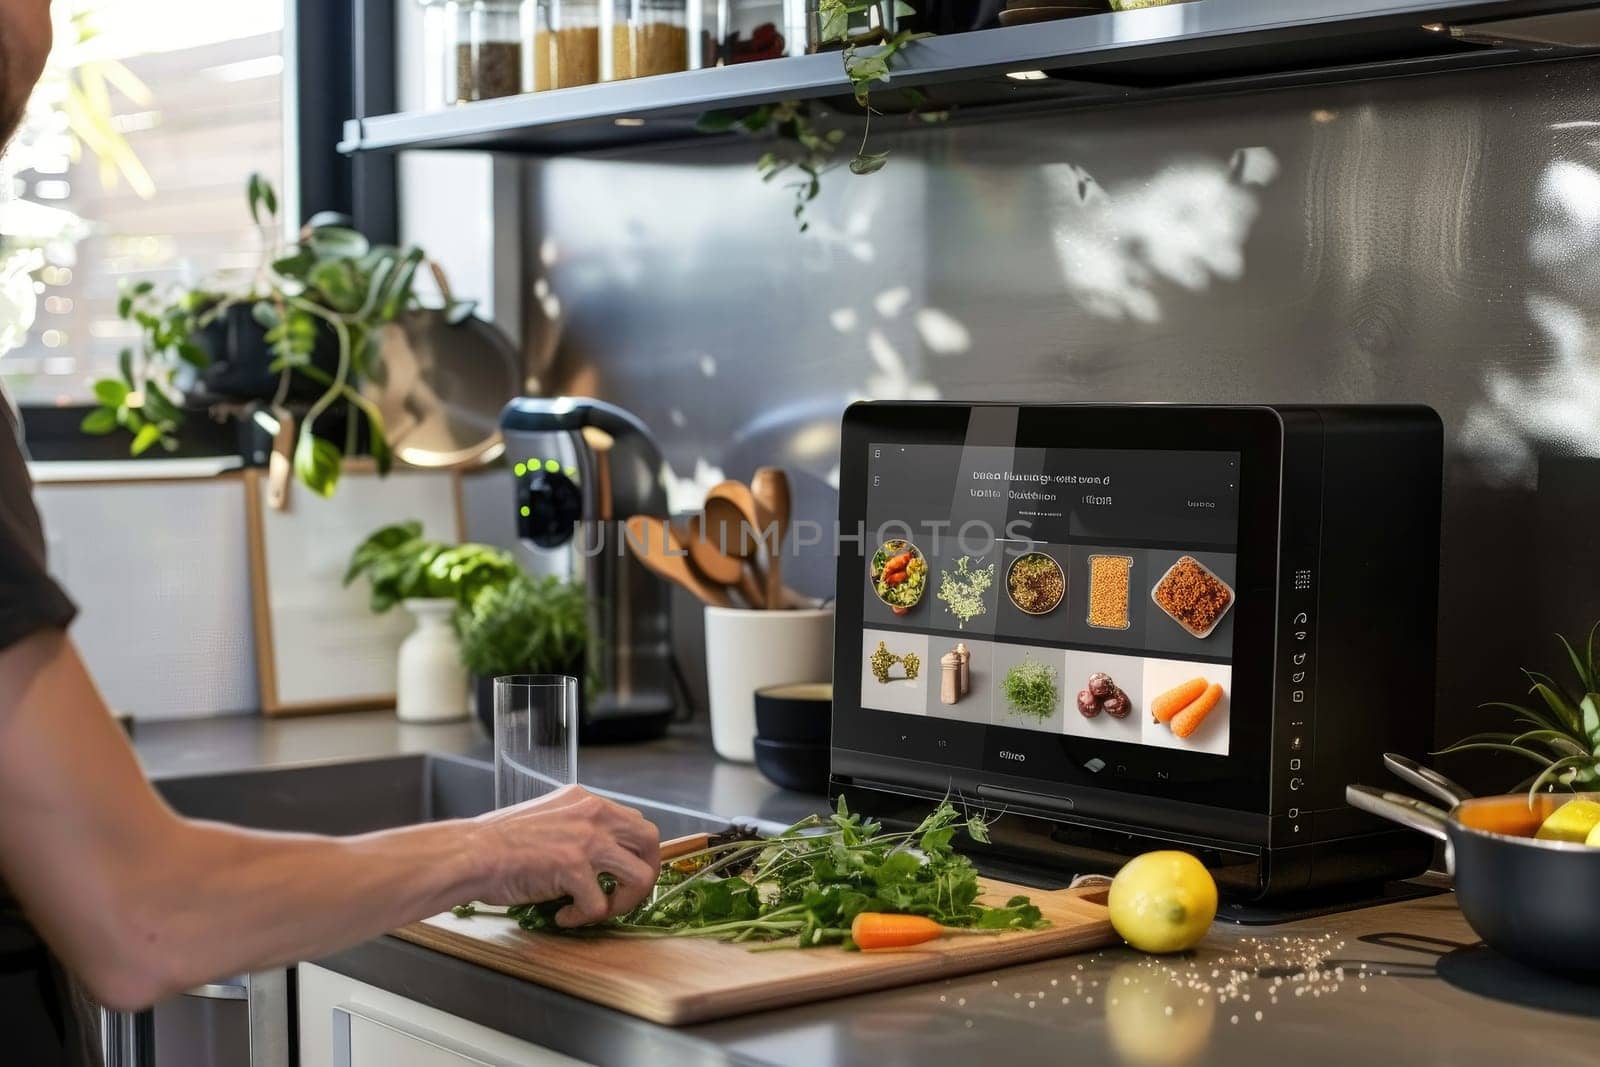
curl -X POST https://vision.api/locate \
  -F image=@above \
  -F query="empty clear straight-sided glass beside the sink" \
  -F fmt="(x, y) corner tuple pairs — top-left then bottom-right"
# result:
(494, 675), (578, 808)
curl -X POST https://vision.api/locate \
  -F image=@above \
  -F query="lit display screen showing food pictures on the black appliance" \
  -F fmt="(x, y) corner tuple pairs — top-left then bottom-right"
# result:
(840, 442), (1240, 757)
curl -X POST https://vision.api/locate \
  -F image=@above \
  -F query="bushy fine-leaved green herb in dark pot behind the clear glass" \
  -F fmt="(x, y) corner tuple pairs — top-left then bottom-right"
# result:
(456, 573), (589, 736)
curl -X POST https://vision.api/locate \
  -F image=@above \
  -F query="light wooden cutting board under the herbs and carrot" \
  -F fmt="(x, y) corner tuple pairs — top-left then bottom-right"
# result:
(394, 878), (1117, 1025)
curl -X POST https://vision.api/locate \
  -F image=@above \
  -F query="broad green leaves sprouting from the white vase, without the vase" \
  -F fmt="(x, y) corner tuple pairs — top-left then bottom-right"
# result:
(344, 520), (522, 614)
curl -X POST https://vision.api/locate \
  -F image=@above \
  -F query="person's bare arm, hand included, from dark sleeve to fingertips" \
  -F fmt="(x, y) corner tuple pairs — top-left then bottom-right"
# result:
(0, 630), (659, 1009)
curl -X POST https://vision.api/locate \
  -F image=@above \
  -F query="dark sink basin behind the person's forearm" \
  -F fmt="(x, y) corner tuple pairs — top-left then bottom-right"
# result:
(155, 755), (726, 838)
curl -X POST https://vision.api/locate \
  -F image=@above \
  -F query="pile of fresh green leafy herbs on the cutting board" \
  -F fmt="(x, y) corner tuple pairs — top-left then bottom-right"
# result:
(512, 797), (1046, 949)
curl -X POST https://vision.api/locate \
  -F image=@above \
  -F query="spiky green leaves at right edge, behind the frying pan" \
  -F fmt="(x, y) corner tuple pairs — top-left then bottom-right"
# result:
(1435, 622), (1600, 801)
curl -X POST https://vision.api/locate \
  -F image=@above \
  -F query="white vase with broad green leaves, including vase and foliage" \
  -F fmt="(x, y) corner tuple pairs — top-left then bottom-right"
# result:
(344, 522), (522, 721)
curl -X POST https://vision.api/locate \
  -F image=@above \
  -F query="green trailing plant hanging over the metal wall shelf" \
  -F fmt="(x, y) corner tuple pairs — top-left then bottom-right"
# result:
(696, 0), (949, 234)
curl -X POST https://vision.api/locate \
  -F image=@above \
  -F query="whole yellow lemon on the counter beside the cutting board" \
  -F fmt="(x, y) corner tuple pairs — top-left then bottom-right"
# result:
(1106, 851), (1216, 952)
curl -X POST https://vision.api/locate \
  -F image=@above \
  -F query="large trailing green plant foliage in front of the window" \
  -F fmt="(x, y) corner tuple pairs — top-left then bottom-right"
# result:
(82, 174), (472, 496)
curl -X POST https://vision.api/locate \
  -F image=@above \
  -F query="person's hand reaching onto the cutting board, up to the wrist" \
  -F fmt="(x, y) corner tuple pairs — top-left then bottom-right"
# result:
(478, 785), (661, 926)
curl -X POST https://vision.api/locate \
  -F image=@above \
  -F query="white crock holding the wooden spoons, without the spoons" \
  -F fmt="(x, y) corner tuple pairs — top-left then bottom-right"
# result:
(706, 608), (834, 763)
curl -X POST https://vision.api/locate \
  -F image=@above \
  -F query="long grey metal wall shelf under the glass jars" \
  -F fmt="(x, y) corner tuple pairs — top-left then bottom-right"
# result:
(339, 0), (1600, 155)
